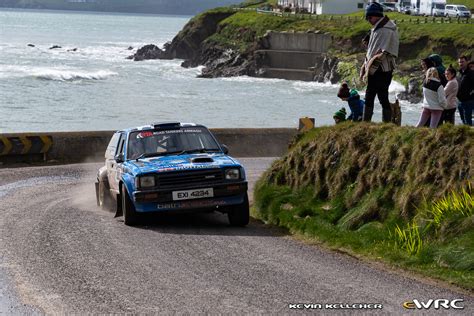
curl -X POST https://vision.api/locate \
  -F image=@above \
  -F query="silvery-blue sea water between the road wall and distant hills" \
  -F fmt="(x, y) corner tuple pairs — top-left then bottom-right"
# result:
(0, 9), (421, 133)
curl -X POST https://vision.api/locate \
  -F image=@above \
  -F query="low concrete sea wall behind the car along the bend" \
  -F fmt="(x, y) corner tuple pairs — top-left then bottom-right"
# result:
(0, 128), (297, 165)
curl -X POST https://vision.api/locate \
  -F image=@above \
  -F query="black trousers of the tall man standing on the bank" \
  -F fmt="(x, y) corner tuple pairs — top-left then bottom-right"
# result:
(364, 68), (392, 122)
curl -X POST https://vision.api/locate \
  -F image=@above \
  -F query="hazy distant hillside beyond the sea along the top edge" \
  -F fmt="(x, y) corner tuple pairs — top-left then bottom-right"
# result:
(0, 0), (242, 15)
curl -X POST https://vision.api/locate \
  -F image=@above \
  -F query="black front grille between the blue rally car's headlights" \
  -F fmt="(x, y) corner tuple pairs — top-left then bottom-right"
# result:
(156, 169), (224, 189)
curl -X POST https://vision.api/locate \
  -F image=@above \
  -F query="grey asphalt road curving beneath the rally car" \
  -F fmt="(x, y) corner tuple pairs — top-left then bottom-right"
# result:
(0, 158), (474, 315)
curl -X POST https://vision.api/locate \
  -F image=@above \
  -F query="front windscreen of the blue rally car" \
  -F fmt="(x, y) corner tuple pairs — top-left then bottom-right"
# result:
(127, 127), (221, 159)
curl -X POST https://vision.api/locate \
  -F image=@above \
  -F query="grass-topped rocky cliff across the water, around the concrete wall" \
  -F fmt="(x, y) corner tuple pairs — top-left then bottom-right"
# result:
(131, 8), (474, 99)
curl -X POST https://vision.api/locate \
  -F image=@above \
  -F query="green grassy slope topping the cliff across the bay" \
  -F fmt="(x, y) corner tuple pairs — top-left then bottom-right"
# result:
(208, 1), (474, 84)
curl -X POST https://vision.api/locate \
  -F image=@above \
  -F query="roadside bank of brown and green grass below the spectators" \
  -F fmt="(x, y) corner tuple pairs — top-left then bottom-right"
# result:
(253, 123), (474, 291)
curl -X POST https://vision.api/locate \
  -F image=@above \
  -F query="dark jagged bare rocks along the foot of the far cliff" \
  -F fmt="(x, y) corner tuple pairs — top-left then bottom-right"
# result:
(128, 11), (422, 103)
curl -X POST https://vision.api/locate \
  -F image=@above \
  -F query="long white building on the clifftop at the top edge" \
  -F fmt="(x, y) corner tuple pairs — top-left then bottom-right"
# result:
(278, 0), (367, 14)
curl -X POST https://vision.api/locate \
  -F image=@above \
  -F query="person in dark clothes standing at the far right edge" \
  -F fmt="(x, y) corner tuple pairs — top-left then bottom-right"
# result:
(457, 56), (474, 126)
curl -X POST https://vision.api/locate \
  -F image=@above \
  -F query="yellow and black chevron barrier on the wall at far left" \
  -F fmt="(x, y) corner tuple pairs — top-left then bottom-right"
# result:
(0, 135), (53, 156)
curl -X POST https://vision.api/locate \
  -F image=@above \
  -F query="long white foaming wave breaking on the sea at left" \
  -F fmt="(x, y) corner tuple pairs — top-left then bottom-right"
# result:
(31, 69), (118, 81)
